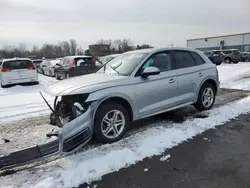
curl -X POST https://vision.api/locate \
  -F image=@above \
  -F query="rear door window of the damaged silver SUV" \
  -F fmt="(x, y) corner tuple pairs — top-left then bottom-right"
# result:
(174, 51), (195, 69)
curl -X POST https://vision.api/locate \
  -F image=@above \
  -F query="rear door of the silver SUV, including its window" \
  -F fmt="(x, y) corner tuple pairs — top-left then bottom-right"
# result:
(173, 50), (204, 105)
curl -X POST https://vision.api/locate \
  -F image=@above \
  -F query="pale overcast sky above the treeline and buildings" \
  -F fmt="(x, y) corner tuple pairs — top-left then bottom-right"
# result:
(0, 0), (250, 49)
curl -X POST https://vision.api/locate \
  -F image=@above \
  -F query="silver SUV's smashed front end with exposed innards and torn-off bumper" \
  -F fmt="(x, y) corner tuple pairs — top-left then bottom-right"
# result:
(0, 94), (96, 170)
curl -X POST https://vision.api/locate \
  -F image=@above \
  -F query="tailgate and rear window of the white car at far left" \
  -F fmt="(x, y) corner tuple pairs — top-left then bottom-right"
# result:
(2, 60), (37, 80)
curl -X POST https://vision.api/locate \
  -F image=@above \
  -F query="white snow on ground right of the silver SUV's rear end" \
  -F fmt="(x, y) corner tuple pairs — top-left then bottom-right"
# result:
(217, 62), (250, 90)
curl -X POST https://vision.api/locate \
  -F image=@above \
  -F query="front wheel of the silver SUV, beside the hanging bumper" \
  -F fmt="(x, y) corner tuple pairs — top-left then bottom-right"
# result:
(94, 102), (129, 143)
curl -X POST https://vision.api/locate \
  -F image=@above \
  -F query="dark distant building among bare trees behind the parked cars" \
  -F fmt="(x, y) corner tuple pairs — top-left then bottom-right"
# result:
(88, 44), (111, 57)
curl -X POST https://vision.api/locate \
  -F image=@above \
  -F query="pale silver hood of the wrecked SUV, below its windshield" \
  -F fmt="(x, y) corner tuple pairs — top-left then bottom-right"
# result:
(44, 73), (127, 96)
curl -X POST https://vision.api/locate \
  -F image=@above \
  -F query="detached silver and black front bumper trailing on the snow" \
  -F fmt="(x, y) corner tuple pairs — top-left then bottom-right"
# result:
(0, 100), (95, 170)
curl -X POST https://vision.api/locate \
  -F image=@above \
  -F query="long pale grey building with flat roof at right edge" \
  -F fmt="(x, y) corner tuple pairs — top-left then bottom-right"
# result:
(187, 32), (250, 51)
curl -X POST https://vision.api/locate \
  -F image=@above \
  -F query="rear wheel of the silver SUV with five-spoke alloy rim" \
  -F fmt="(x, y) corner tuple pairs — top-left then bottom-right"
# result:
(194, 83), (216, 111)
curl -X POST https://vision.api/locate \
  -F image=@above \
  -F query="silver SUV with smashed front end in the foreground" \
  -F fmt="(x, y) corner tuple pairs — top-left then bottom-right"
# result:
(44, 47), (219, 144)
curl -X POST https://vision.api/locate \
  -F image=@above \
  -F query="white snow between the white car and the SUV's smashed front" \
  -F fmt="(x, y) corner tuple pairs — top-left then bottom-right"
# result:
(0, 74), (57, 124)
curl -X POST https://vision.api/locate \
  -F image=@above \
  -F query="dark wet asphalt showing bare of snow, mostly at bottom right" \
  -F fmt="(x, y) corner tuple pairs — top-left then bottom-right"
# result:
(79, 90), (250, 188)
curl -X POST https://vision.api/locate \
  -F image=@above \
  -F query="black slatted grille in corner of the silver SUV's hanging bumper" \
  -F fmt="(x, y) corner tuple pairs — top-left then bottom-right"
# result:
(63, 128), (91, 152)
